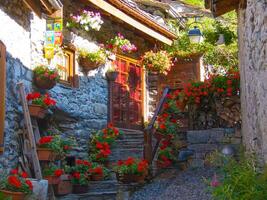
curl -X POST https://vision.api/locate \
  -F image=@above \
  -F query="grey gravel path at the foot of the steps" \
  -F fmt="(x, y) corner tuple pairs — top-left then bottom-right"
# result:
(130, 169), (214, 200)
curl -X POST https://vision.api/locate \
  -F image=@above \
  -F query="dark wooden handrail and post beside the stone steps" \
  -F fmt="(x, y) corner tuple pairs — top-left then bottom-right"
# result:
(144, 87), (170, 164)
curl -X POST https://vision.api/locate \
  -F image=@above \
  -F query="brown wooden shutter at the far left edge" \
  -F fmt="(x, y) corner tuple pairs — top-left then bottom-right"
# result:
(0, 41), (6, 153)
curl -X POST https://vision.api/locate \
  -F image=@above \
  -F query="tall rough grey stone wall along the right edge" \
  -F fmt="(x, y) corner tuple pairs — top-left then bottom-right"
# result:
(239, 0), (267, 162)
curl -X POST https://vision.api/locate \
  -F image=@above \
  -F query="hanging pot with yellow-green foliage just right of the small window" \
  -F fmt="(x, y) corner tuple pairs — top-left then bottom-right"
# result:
(78, 48), (107, 73)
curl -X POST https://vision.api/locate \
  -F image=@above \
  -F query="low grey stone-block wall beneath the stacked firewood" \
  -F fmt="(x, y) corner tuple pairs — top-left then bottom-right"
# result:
(186, 128), (242, 168)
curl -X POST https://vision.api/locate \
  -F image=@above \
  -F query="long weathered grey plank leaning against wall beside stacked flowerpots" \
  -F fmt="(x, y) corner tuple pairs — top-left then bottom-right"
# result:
(18, 82), (42, 179)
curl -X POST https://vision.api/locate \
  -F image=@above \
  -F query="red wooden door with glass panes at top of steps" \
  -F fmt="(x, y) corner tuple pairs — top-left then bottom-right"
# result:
(111, 57), (143, 129)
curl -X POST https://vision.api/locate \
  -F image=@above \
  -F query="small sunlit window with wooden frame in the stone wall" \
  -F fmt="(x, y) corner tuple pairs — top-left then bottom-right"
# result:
(51, 48), (78, 87)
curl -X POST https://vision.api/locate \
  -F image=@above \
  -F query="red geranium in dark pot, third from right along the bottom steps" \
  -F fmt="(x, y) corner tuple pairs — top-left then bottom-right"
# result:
(70, 160), (92, 194)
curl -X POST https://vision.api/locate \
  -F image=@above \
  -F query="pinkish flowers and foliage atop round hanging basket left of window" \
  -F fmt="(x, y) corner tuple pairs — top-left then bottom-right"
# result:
(33, 65), (60, 81)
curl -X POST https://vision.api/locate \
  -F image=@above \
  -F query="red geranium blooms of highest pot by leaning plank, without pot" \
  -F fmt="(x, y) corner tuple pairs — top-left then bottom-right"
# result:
(26, 92), (56, 108)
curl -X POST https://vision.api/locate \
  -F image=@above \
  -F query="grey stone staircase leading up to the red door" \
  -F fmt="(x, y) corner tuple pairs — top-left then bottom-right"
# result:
(57, 129), (144, 200)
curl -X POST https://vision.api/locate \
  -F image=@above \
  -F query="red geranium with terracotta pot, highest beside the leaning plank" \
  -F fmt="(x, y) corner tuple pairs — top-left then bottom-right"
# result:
(26, 92), (56, 119)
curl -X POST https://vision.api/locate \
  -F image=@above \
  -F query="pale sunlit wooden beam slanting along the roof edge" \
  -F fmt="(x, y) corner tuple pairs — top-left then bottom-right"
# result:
(88, 0), (173, 45)
